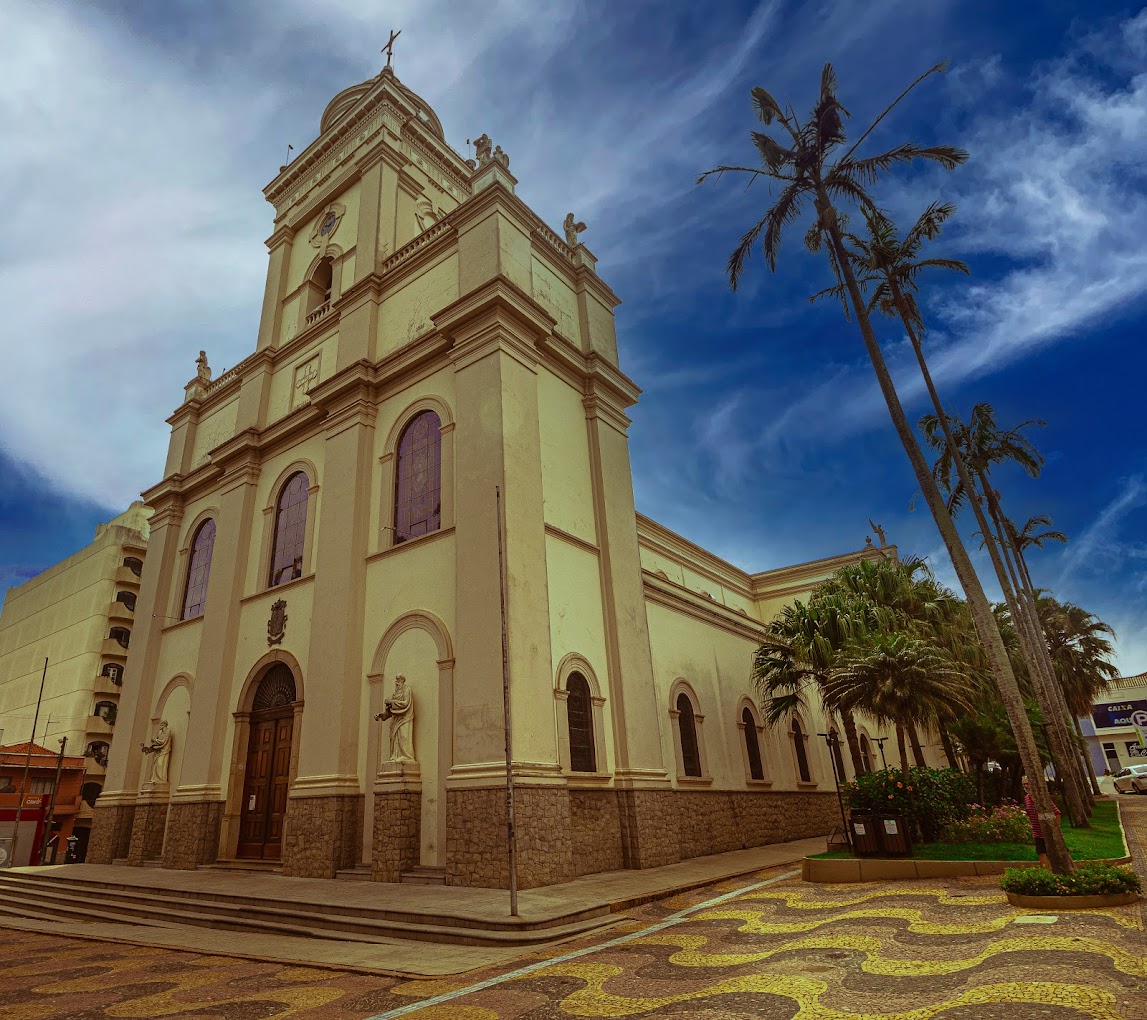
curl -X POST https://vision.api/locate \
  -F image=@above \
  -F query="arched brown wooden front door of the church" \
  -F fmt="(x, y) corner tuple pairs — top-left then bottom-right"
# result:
(236, 662), (295, 861)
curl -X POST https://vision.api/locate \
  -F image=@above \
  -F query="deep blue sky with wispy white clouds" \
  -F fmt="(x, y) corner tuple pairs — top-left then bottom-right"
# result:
(0, 0), (1147, 673)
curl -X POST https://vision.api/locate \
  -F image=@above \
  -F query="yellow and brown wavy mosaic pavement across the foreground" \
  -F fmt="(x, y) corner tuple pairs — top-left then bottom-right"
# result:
(0, 799), (1147, 1020)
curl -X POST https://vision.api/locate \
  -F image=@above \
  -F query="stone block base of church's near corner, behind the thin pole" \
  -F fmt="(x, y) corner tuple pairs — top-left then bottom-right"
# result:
(446, 786), (574, 889)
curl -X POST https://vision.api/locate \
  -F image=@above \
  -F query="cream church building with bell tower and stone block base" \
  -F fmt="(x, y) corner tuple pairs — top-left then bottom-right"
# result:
(88, 68), (913, 887)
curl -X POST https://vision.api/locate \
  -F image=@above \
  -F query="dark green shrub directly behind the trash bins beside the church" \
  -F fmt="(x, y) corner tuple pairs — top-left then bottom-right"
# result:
(841, 765), (976, 842)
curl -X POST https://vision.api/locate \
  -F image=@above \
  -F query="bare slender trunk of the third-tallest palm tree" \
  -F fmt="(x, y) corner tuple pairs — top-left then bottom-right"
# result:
(976, 486), (1091, 827)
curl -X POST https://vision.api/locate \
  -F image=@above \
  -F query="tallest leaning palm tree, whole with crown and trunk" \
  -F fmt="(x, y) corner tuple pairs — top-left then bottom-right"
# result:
(699, 64), (1071, 873)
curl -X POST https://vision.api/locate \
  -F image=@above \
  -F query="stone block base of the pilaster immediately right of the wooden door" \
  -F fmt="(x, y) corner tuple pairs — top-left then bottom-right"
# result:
(282, 794), (364, 879)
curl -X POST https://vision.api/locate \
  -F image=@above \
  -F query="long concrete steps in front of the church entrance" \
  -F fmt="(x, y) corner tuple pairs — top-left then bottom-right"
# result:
(0, 873), (616, 945)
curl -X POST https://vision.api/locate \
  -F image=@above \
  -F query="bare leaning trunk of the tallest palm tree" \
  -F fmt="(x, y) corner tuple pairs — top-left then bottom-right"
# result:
(817, 192), (1071, 874)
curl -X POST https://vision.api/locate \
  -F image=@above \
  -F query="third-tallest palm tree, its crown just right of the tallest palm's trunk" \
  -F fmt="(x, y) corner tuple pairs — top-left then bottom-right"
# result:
(921, 403), (1091, 826)
